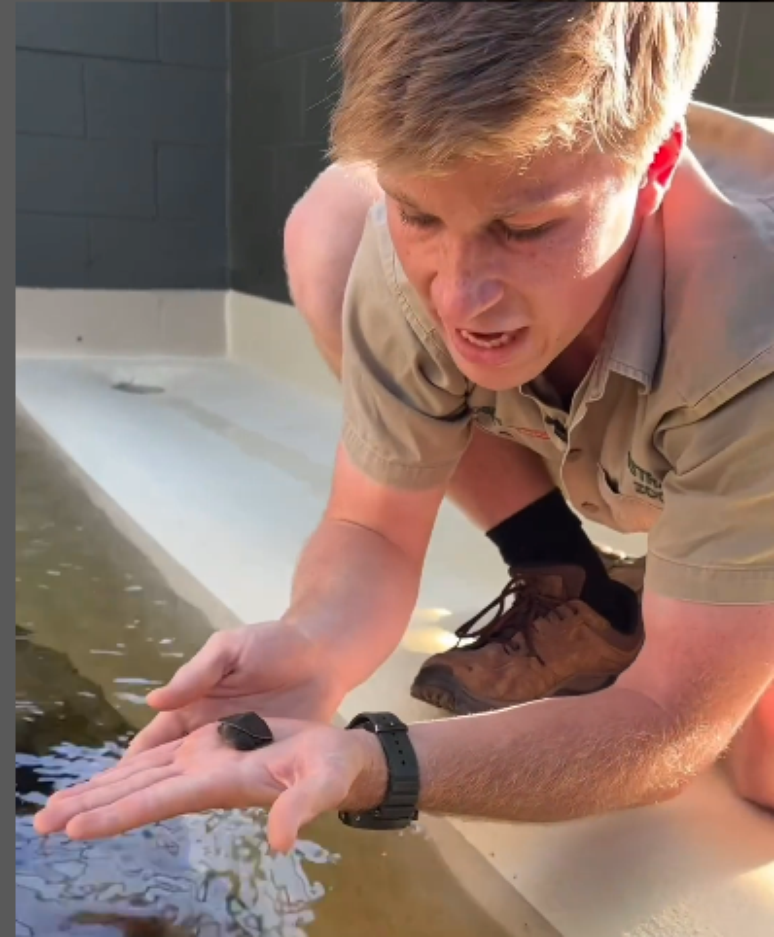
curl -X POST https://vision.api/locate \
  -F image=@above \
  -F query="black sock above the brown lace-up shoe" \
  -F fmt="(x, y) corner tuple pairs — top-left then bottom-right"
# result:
(487, 488), (636, 633)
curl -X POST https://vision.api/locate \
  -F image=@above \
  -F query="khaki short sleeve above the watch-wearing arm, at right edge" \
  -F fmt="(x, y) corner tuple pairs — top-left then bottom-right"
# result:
(645, 374), (774, 605)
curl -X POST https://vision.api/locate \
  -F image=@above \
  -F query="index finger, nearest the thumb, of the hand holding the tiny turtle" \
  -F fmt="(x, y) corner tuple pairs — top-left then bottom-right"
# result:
(65, 775), (224, 840)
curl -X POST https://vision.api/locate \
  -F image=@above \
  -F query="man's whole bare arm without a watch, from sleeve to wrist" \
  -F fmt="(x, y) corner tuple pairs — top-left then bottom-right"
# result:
(283, 446), (445, 694)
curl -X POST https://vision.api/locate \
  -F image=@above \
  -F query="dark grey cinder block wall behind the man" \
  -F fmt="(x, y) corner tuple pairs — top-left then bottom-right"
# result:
(16, 2), (774, 301)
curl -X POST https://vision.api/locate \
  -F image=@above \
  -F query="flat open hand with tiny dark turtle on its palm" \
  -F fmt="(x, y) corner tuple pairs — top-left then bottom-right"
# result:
(35, 719), (387, 852)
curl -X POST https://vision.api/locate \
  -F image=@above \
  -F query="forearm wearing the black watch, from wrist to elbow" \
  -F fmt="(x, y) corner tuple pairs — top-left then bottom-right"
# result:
(351, 688), (711, 823)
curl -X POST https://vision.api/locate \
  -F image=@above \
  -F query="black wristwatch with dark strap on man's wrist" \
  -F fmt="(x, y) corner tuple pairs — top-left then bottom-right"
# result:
(339, 713), (419, 830)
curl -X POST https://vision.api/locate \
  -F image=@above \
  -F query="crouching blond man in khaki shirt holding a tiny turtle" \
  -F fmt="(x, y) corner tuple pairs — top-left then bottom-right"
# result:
(36, 2), (774, 849)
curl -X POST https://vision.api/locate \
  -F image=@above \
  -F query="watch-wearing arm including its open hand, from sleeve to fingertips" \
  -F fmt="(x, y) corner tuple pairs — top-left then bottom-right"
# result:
(35, 587), (774, 851)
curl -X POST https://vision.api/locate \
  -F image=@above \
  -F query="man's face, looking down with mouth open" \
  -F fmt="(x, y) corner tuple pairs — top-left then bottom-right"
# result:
(379, 154), (640, 390)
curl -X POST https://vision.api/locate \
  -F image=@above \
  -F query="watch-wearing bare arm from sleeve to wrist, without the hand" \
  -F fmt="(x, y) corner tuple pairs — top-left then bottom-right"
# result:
(347, 594), (774, 822)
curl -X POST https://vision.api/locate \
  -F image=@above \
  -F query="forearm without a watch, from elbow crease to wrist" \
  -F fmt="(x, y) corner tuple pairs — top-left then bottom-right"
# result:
(283, 519), (421, 693)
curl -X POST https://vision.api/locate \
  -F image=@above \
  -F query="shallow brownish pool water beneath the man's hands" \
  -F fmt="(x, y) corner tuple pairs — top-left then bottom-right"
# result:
(16, 420), (525, 937)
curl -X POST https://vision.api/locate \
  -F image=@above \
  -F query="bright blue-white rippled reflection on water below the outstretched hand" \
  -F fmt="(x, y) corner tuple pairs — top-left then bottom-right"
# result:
(16, 808), (328, 937)
